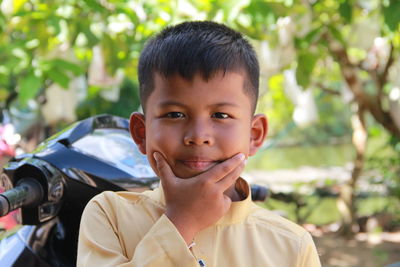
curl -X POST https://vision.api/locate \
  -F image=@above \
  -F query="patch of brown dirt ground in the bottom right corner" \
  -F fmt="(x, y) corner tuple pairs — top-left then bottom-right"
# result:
(313, 232), (400, 267)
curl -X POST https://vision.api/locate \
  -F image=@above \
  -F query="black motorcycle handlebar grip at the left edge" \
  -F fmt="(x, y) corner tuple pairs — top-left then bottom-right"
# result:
(0, 178), (44, 217)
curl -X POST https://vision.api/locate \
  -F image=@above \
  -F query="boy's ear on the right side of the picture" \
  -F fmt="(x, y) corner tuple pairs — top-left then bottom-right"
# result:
(249, 114), (268, 156)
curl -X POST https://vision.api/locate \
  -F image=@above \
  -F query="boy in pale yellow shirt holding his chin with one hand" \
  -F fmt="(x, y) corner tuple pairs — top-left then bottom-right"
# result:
(78, 22), (320, 267)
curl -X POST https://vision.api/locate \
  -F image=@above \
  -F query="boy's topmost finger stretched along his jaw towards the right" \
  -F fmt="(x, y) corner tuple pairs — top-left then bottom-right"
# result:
(199, 153), (245, 182)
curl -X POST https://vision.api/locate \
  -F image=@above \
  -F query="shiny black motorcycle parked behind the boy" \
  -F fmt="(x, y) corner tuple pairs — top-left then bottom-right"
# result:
(0, 115), (268, 267)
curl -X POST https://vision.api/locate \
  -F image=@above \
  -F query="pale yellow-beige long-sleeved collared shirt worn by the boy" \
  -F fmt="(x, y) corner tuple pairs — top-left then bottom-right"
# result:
(77, 180), (320, 267)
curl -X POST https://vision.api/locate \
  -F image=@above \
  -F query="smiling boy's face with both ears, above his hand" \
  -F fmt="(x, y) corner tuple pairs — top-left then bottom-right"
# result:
(131, 72), (267, 178)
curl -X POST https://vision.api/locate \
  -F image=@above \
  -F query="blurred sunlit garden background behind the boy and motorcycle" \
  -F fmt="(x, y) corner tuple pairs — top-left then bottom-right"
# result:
(0, 0), (400, 266)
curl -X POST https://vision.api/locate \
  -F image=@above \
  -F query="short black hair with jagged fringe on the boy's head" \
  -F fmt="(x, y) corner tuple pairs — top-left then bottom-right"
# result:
(138, 21), (260, 112)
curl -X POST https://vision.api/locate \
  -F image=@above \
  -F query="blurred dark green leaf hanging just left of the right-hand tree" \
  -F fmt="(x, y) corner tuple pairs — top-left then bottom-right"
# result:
(296, 51), (318, 88)
